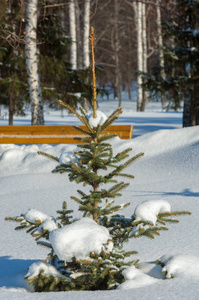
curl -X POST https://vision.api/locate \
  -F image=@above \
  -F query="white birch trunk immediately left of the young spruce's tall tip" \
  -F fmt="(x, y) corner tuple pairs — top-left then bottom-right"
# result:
(83, 0), (90, 68)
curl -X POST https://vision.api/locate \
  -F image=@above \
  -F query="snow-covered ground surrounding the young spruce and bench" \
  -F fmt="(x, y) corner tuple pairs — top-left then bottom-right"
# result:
(0, 97), (199, 300)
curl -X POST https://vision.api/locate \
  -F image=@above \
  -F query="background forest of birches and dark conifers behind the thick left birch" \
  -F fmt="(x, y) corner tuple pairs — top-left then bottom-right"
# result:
(0, 0), (199, 126)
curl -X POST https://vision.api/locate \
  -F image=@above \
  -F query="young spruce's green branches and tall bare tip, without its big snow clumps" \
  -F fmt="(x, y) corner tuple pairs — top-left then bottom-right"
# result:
(7, 29), (190, 292)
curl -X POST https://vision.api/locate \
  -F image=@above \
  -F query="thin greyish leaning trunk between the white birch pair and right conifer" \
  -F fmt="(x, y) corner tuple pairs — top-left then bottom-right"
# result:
(156, 0), (166, 107)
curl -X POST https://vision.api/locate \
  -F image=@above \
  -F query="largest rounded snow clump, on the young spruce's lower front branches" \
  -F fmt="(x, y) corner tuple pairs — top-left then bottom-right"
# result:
(49, 218), (112, 261)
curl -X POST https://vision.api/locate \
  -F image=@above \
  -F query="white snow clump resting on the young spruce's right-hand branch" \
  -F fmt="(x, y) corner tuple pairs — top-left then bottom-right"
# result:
(133, 200), (171, 225)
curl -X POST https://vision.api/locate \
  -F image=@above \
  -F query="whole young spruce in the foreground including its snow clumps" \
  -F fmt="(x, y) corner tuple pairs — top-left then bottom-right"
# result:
(7, 27), (189, 292)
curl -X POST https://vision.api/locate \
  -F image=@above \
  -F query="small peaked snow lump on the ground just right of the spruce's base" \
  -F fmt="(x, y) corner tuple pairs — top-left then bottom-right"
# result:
(118, 266), (159, 290)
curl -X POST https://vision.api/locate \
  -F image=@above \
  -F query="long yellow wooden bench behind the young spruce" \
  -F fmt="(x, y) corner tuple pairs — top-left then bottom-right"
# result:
(0, 125), (133, 144)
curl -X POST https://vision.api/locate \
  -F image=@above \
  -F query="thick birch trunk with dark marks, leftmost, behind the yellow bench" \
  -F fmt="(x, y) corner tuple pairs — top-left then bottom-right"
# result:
(25, 0), (44, 125)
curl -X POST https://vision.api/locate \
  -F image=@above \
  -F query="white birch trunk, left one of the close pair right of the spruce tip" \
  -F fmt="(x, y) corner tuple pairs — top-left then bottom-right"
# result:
(137, 1), (143, 111)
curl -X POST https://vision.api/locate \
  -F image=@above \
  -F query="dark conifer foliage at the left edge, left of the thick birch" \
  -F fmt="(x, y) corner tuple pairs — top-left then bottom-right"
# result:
(0, 1), (29, 124)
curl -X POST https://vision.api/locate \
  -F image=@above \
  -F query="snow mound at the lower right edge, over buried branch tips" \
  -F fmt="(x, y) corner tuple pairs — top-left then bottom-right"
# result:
(159, 254), (199, 279)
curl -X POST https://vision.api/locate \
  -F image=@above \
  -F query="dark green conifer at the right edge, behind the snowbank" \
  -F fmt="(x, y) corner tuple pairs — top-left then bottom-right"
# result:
(143, 0), (199, 127)
